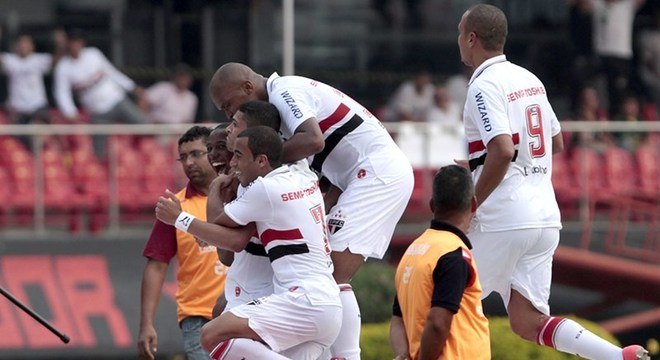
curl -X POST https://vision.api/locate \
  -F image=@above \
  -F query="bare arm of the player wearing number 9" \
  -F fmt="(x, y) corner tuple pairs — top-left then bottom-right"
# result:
(474, 134), (514, 205)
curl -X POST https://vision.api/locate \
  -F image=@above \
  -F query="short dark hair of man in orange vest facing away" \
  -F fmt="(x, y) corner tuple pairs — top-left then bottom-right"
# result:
(432, 165), (474, 218)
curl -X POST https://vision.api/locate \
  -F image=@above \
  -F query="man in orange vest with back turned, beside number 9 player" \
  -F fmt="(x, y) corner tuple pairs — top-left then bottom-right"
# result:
(390, 165), (490, 360)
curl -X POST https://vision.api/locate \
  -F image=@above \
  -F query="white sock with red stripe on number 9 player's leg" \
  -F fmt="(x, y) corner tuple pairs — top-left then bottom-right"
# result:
(536, 317), (622, 359)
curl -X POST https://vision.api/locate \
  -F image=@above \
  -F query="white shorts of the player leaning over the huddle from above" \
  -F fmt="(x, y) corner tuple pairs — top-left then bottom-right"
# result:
(327, 169), (415, 259)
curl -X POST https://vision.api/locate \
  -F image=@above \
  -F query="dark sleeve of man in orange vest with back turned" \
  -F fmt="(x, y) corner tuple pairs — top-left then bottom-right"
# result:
(431, 248), (470, 314)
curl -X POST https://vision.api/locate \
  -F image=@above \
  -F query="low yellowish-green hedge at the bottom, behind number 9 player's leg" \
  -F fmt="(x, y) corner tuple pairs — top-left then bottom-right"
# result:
(360, 316), (619, 360)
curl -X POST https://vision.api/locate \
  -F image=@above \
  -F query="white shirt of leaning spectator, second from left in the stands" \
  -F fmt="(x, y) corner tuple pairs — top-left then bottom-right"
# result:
(55, 47), (135, 117)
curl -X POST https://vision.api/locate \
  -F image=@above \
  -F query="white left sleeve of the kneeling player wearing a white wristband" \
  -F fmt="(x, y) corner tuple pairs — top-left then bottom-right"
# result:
(224, 179), (273, 225)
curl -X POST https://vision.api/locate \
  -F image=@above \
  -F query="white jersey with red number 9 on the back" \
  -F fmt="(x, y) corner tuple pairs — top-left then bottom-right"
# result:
(463, 55), (561, 231)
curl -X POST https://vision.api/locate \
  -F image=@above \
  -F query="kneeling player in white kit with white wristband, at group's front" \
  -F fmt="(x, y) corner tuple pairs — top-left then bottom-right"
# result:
(156, 126), (342, 360)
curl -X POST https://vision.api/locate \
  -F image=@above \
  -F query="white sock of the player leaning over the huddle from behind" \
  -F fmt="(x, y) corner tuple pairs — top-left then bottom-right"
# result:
(330, 284), (362, 360)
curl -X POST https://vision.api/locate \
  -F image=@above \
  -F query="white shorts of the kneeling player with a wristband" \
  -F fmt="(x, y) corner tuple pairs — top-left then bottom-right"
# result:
(230, 291), (342, 359)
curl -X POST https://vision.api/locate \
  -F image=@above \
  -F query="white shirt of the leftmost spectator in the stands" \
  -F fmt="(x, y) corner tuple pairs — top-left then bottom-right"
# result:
(2, 53), (53, 113)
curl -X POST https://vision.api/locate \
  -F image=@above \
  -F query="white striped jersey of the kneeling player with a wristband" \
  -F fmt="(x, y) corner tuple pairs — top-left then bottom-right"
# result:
(224, 166), (341, 305)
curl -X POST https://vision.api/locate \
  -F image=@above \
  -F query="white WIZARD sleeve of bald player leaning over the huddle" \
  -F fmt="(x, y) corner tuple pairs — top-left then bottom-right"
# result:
(268, 83), (317, 134)
